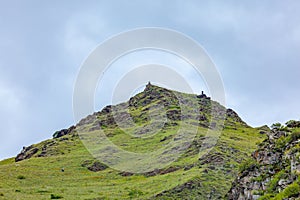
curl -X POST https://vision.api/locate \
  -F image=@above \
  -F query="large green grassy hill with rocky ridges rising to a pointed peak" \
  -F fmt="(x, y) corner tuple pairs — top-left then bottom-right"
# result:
(0, 85), (265, 199)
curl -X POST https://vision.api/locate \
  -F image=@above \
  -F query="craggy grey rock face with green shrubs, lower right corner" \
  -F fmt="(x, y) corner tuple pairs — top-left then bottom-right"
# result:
(226, 123), (300, 200)
